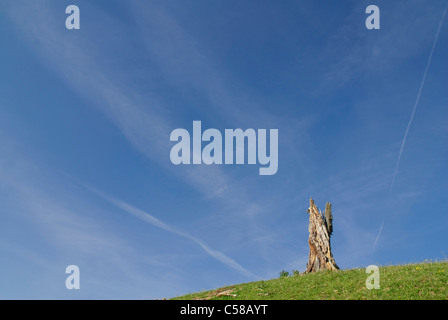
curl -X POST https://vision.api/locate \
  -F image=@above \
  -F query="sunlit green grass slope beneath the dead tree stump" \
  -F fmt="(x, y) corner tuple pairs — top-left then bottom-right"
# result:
(173, 261), (448, 300)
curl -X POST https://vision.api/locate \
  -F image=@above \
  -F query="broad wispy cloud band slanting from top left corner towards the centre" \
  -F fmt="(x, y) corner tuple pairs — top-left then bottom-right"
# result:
(1, 1), (270, 205)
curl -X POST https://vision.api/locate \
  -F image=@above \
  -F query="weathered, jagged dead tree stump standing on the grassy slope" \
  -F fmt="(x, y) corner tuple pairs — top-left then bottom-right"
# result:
(305, 199), (339, 273)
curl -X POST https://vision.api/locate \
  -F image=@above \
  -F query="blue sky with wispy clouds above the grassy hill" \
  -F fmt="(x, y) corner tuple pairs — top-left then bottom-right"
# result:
(0, 0), (448, 299)
